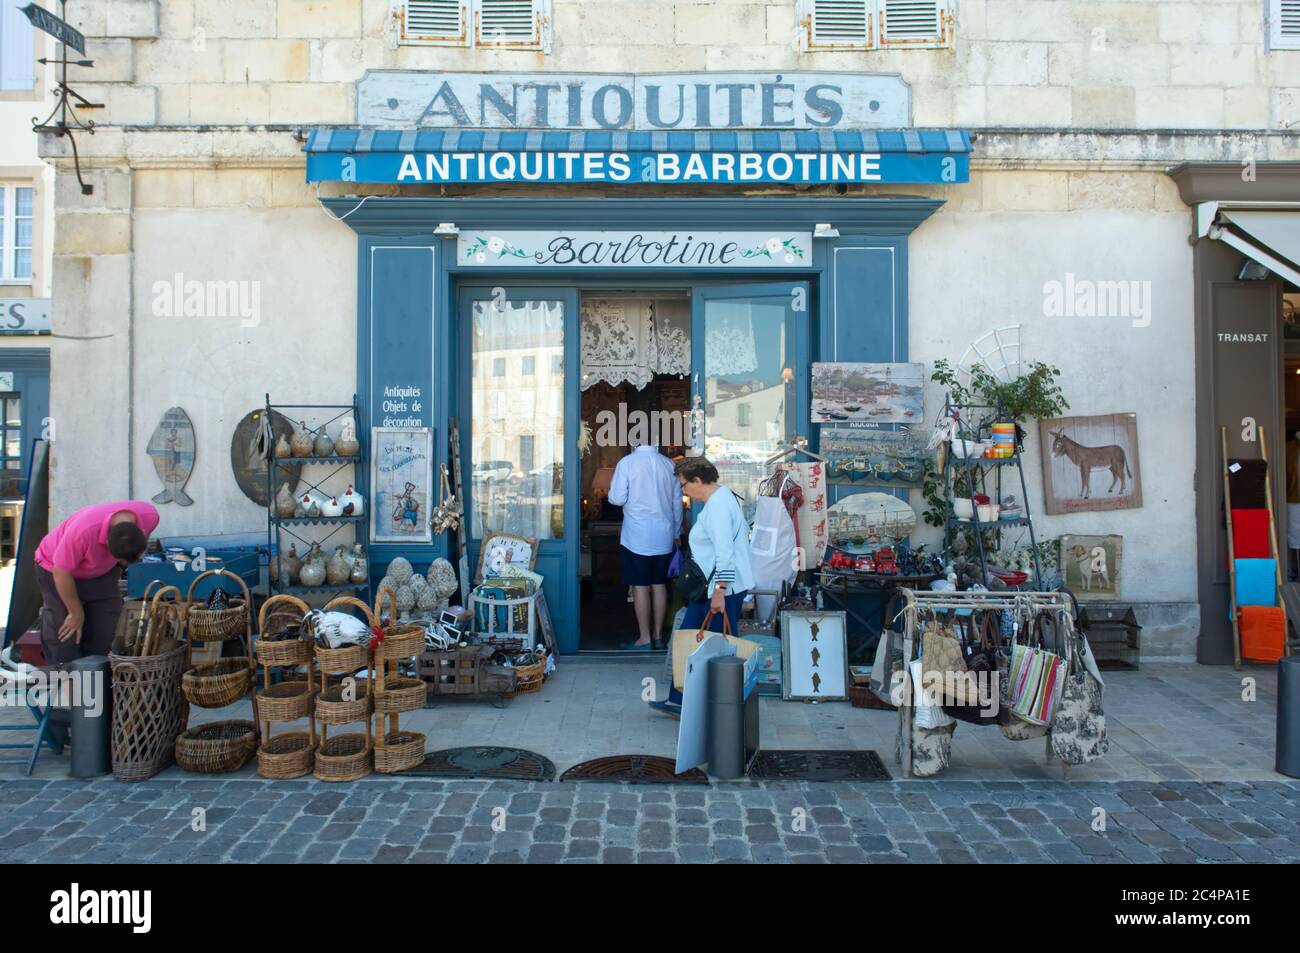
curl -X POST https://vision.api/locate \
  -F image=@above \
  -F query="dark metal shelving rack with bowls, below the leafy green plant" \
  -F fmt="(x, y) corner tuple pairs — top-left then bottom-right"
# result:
(944, 398), (1043, 590)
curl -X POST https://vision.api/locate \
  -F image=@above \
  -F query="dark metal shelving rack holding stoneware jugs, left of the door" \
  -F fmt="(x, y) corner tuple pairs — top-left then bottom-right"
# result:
(267, 394), (371, 603)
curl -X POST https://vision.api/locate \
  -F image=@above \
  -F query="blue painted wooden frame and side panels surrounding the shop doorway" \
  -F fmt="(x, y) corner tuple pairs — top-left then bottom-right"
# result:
(340, 196), (943, 653)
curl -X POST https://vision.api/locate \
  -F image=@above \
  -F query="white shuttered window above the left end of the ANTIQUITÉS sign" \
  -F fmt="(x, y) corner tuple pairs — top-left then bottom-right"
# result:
(399, 0), (551, 52)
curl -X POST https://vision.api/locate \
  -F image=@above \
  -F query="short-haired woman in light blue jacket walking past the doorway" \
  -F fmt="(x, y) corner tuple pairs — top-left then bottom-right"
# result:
(650, 456), (754, 718)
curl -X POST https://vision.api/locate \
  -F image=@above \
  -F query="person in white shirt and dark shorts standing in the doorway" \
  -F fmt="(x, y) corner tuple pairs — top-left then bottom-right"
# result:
(610, 436), (681, 651)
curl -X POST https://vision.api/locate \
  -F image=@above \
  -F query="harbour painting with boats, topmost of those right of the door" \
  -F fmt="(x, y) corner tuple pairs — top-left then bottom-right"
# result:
(813, 361), (926, 424)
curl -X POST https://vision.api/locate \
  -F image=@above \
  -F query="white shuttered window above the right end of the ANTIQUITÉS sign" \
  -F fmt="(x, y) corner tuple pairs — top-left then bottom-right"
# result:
(797, 0), (957, 52)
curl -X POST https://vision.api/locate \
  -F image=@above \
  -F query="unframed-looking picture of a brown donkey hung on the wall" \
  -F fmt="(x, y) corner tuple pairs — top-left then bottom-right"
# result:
(1039, 413), (1141, 515)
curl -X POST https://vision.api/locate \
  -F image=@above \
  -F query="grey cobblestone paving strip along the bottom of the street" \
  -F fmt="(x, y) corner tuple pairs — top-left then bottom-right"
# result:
(0, 779), (1300, 863)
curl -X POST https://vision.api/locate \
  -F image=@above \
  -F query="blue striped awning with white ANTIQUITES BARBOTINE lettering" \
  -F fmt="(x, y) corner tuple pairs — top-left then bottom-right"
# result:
(304, 127), (971, 185)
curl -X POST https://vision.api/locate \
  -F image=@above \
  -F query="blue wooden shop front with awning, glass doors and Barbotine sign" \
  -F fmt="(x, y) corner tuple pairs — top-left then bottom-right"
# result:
(306, 74), (970, 653)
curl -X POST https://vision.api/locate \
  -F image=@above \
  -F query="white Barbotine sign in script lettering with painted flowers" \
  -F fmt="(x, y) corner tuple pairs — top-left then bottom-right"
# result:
(456, 230), (813, 268)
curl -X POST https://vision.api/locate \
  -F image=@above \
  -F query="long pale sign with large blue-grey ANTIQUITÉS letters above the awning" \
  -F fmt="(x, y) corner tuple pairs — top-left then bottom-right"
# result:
(356, 70), (911, 131)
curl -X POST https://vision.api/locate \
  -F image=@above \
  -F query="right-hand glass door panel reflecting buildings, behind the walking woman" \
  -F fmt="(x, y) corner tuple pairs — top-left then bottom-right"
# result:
(693, 282), (807, 519)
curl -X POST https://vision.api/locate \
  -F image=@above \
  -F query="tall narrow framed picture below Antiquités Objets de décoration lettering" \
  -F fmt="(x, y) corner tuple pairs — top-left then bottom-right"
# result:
(371, 426), (433, 543)
